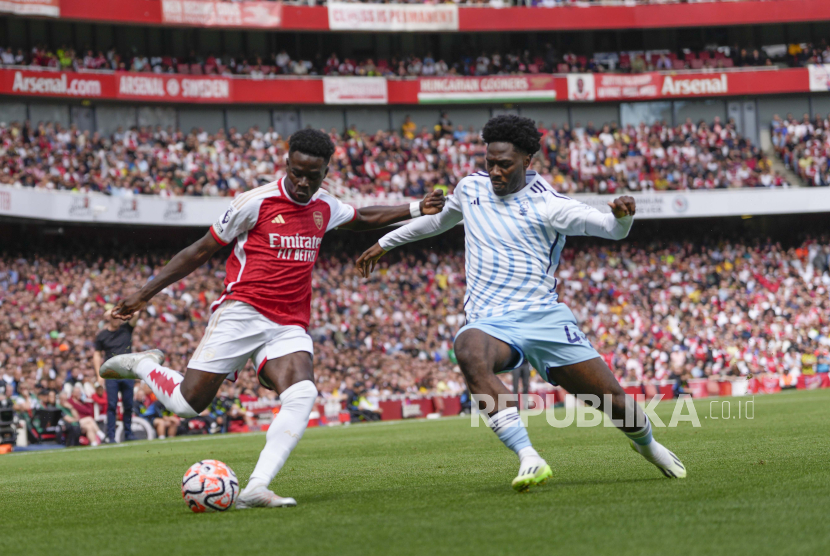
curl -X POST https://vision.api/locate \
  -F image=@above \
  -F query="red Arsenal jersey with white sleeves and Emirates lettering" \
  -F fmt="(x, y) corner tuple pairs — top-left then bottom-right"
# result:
(210, 178), (357, 329)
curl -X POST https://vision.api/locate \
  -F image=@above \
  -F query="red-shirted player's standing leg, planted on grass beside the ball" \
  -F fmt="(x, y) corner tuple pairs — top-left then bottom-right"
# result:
(236, 351), (317, 509)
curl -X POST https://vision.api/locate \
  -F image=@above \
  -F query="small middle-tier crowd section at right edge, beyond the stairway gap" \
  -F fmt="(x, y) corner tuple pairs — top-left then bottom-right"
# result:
(770, 114), (830, 186)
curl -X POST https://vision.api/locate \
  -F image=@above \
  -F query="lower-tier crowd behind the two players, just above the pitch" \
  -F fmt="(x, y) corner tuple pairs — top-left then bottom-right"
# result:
(0, 231), (830, 443)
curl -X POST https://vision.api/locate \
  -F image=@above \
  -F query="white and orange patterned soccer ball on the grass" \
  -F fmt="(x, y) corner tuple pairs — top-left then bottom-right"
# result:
(182, 459), (239, 513)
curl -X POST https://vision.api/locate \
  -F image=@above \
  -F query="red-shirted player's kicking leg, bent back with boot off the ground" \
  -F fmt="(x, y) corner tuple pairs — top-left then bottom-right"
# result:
(101, 349), (226, 418)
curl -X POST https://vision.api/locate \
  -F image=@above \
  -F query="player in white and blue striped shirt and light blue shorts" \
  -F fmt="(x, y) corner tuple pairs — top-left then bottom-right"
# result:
(357, 115), (686, 492)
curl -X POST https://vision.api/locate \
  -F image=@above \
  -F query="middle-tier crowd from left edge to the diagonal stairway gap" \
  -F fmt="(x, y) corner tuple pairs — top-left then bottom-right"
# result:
(0, 113), (788, 198)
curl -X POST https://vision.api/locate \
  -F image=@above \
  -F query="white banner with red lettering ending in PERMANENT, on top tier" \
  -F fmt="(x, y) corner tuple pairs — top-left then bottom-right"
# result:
(328, 2), (458, 31)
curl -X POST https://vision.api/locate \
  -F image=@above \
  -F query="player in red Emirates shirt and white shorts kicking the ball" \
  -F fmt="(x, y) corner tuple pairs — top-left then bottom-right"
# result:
(101, 129), (444, 508)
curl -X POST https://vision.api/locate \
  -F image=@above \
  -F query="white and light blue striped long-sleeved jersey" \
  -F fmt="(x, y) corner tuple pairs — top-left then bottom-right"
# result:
(379, 171), (633, 322)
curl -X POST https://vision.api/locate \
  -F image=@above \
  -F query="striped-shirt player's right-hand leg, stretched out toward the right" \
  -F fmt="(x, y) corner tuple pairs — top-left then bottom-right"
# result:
(548, 357), (686, 479)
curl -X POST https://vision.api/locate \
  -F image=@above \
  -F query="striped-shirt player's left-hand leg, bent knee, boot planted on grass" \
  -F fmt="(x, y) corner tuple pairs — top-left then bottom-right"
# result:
(455, 328), (552, 492)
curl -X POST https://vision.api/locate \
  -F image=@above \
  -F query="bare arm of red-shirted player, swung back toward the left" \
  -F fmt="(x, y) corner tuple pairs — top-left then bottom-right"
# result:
(112, 232), (222, 320)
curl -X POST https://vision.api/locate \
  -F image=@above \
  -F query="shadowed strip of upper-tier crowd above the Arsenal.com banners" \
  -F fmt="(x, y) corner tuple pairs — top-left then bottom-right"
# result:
(0, 41), (830, 79)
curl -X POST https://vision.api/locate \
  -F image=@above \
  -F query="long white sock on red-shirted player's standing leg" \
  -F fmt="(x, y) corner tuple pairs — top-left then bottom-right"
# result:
(245, 380), (317, 490)
